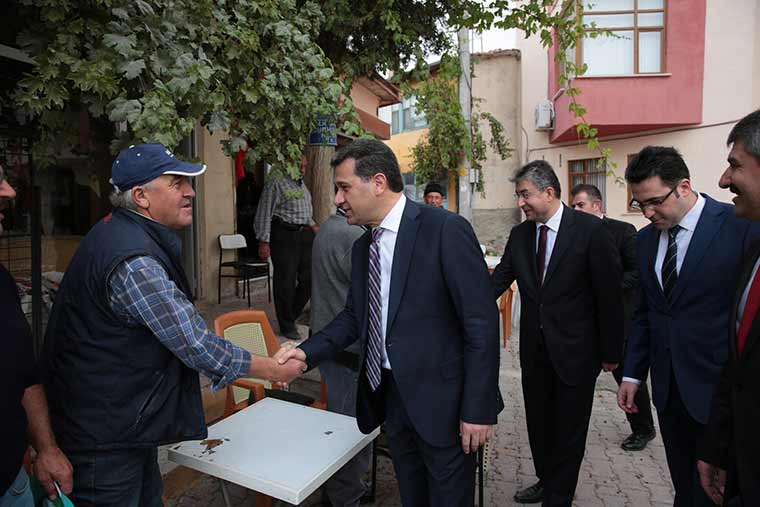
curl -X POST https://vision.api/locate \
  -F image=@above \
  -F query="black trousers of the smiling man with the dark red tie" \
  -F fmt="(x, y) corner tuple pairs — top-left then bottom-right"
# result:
(522, 344), (596, 507)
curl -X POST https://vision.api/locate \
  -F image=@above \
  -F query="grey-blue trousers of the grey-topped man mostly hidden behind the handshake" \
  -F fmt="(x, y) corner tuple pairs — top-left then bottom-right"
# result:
(319, 361), (372, 507)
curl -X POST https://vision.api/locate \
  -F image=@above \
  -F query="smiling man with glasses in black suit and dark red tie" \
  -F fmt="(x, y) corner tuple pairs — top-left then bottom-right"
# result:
(491, 160), (623, 506)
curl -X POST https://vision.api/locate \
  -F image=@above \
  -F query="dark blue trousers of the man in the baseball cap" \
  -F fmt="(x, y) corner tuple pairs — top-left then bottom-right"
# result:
(66, 447), (164, 507)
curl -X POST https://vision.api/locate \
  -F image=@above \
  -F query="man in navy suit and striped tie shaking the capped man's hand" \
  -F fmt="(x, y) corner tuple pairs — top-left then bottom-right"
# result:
(278, 139), (504, 507)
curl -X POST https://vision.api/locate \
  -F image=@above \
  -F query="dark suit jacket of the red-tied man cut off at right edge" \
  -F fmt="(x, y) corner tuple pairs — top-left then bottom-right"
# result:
(698, 243), (760, 506)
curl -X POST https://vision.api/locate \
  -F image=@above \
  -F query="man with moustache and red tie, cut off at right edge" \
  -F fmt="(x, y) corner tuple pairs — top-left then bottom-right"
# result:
(697, 111), (760, 507)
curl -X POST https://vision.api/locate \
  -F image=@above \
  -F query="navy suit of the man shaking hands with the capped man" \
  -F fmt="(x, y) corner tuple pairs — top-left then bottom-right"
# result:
(300, 201), (504, 507)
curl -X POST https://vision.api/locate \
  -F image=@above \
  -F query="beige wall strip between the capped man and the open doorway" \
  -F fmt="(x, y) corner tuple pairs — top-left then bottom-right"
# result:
(196, 129), (235, 302)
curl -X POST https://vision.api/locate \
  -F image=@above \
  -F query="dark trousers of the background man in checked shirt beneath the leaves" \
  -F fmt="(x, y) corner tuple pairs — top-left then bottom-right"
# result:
(269, 219), (314, 334)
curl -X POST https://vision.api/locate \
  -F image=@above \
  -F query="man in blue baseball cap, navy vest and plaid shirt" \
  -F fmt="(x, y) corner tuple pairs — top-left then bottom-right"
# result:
(42, 144), (305, 507)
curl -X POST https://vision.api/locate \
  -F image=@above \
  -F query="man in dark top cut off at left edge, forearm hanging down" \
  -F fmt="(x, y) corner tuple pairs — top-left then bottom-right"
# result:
(0, 166), (71, 507)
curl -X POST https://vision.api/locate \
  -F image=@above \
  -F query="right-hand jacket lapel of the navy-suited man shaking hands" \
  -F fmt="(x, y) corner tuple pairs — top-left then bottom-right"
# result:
(385, 200), (420, 336)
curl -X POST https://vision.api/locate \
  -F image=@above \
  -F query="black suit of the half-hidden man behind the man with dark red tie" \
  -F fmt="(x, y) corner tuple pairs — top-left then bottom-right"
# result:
(602, 217), (654, 434)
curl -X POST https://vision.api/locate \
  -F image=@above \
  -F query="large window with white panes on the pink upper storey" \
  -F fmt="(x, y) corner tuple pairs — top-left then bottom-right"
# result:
(567, 0), (665, 76)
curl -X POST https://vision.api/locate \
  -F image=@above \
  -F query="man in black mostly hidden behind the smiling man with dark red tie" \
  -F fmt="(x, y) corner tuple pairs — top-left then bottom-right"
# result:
(570, 183), (655, 451)
